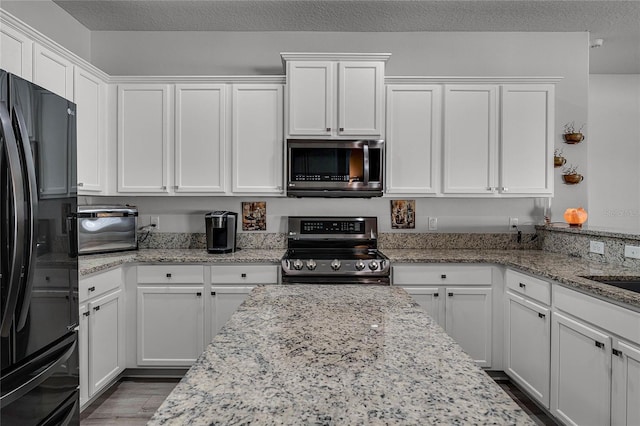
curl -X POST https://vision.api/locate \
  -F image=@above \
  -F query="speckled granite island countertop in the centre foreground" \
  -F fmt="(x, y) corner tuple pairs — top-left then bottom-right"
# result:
(148, 285), (534, 425)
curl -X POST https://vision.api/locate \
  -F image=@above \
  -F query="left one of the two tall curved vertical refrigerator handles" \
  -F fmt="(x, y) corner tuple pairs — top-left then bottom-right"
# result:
(0, 102), (25, 337)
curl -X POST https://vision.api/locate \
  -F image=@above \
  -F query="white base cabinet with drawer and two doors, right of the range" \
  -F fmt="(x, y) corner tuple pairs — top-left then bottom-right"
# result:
(393, 265), (493, 367)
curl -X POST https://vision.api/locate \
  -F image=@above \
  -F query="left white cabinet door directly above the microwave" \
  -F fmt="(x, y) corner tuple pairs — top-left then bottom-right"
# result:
(287, 61), (337, 136)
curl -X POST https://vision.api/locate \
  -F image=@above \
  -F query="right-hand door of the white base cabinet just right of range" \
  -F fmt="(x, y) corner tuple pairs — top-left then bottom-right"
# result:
(445, 287), (493, 367)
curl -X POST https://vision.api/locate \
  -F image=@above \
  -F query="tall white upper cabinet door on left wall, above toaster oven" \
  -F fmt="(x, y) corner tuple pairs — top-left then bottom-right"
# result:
(74, 67), (106, 195)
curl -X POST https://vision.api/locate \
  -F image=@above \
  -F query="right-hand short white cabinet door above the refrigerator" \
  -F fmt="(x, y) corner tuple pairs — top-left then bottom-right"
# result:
(33, 43), (74, 100)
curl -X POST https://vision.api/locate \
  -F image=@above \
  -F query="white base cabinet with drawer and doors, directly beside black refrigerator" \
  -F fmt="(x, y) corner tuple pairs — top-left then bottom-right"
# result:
(79, 269), (125, 406)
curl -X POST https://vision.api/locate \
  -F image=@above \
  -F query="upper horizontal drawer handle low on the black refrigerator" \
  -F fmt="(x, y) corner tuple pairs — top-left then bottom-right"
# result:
(0, 333), (78, 409)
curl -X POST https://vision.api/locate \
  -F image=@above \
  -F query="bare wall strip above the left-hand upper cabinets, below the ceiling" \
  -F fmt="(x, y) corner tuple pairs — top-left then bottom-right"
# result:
(0, 0), (91, 61)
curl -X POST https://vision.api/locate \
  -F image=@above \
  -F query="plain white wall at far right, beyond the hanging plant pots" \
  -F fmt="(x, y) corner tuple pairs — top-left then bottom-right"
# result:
(585, 74), (640, 234)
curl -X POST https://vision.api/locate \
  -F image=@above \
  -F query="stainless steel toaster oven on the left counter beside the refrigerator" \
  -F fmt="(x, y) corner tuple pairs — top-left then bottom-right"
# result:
(72, 206), (138, 254)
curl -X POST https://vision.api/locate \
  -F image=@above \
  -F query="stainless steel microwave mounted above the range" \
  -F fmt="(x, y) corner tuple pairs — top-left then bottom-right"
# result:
(287, 139), (384, 198)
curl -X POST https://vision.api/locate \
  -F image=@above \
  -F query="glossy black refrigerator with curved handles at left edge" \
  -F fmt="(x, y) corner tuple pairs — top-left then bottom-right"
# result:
(0, 70), (79, 426)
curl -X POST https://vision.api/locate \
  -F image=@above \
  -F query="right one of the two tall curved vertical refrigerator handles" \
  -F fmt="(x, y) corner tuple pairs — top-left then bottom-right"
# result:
(13, 107), (38, 331)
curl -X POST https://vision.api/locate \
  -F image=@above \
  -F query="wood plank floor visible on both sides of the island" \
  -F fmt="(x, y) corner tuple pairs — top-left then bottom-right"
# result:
(80, 377), (558, 426)
